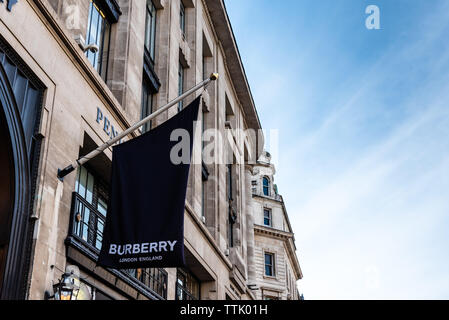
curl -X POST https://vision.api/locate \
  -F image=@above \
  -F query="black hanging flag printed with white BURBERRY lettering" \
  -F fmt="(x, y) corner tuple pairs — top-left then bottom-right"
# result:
(98, 98), (200, 269)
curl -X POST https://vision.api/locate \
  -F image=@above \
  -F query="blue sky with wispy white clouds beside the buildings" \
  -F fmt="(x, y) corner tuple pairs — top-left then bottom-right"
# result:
(225, 0), (449, 299)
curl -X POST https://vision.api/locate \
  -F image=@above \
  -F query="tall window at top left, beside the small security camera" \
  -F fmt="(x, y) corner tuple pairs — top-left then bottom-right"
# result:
(86, 1), (111, 81)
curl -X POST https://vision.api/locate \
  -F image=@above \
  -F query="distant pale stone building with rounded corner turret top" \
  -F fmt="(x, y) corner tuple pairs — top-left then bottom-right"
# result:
(249, 152), (302, 300)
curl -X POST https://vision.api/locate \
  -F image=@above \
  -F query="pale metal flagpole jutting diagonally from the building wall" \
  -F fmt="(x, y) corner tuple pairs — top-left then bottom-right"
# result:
(58, 73), (218, 181)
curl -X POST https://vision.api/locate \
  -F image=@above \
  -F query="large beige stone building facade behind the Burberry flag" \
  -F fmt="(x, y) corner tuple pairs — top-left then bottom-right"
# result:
(0, 0), (300, 300)
